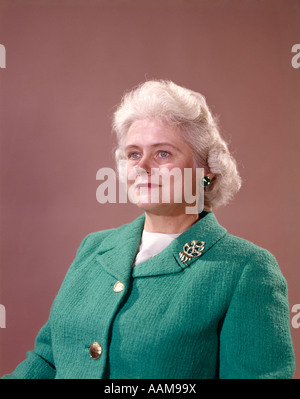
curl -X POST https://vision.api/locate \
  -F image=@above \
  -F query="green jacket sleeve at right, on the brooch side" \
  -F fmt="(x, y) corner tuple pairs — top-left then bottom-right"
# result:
(219, 250), (295, 379)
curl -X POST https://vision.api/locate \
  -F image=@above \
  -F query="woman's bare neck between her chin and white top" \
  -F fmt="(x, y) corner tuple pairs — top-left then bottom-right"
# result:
(144, 212), (199, 234)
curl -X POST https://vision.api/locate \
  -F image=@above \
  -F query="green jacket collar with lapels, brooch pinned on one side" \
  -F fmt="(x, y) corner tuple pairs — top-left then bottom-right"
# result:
(97, 211), (227, 284)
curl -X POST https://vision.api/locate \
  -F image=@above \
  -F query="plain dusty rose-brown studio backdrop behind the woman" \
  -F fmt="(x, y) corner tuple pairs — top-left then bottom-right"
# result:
(0, 0), (300, 378)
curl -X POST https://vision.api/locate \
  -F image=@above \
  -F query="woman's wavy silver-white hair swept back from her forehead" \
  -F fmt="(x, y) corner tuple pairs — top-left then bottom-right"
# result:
(113, 80), (241, 209)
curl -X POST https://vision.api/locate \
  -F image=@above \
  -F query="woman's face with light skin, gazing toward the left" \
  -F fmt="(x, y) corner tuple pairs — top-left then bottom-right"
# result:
(125, 119), (202, 215)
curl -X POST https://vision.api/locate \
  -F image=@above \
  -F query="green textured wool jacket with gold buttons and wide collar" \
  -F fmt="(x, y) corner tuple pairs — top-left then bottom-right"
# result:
(3, 212), (295, 379)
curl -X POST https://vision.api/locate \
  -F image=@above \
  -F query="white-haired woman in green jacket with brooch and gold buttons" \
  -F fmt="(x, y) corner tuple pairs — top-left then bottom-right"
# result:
(1, 81), (294, 379)
